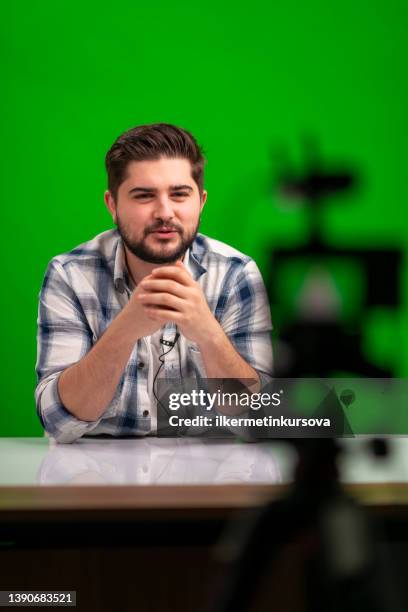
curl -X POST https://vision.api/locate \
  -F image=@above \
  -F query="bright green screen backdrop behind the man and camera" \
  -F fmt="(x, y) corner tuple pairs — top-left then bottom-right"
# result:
(0, 0), (408, 436)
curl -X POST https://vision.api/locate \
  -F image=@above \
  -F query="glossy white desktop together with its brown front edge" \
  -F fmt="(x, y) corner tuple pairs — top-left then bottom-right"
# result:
(0, 437), (408, 511)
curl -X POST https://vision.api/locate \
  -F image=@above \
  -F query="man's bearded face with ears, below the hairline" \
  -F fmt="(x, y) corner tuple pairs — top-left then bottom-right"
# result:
(105, 157), (207, 264)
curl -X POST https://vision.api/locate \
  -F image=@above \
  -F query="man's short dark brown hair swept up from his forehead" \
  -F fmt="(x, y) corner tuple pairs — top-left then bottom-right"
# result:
(105, 123), (205, 200)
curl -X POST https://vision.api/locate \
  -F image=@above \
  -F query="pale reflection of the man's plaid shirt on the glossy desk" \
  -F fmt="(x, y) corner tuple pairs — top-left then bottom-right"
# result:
(38, 438), (281, 485)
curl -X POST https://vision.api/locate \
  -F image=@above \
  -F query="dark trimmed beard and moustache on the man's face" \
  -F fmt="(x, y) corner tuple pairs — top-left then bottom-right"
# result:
(117, 215), (200, 264)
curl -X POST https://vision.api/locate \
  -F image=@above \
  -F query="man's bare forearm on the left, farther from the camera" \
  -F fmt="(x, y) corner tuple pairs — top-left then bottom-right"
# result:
(58, 307), (141, 421)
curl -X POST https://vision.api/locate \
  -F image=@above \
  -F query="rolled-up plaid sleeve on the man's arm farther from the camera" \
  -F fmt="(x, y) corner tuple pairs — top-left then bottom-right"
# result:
(35, 259), (104, 442)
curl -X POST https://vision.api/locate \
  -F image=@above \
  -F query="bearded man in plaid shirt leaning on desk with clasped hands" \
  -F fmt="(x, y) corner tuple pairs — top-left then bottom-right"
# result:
(36, 124), (272, 442)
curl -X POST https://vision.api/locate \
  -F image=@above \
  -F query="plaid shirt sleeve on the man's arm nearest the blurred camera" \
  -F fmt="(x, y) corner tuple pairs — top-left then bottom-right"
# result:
(221, 260), (273, 387)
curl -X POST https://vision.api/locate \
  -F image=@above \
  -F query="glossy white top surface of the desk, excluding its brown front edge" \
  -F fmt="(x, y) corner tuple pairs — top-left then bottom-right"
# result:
(0, 437), (408, 486)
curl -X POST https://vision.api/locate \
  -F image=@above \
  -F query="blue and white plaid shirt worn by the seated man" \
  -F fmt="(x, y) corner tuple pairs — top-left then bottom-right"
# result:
(35, 230), (272, 442)
